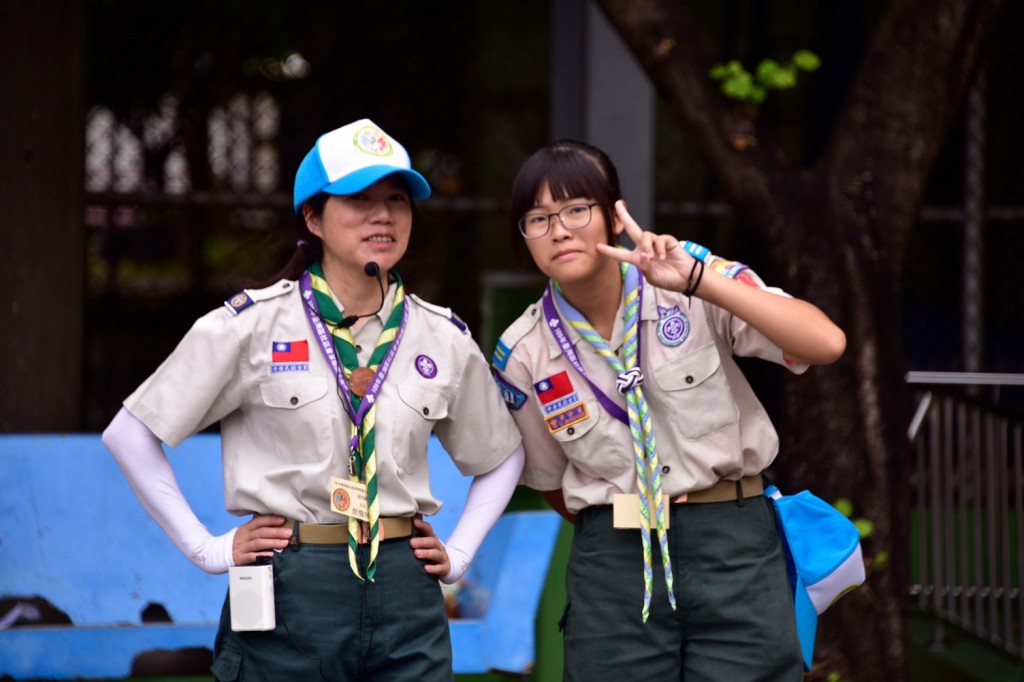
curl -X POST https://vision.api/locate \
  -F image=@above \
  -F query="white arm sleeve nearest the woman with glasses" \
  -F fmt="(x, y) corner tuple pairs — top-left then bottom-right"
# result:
(441, 443), (526, 585)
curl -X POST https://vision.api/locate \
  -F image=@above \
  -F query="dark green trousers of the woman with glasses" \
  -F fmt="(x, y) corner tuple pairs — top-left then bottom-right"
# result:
(564, 496), (803, 682)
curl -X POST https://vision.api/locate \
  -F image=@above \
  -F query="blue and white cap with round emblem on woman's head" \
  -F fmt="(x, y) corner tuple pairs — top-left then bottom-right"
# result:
(293, 119), (430, 213)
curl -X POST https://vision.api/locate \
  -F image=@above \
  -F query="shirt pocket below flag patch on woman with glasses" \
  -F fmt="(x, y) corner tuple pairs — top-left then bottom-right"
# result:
(545, 399), (633, 480)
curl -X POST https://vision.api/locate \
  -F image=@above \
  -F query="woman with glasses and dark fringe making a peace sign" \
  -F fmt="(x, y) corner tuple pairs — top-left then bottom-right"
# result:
(492, 140), (846, 681)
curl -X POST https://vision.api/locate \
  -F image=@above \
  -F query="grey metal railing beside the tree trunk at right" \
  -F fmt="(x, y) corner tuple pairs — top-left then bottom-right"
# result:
(906, 372), (1024, 659)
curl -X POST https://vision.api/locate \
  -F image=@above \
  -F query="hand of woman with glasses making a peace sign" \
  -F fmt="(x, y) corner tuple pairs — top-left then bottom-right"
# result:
(597, 201), (694, 292)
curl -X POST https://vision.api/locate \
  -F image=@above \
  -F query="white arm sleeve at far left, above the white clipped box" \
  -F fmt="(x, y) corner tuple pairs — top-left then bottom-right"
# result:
(103, 408), (238, 573)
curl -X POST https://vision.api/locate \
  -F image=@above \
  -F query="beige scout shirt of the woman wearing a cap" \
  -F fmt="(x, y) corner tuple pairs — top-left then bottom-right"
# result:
(125, 281), (520, 523)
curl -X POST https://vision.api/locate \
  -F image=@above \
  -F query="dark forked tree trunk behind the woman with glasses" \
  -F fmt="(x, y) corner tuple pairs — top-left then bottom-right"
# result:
(598, 0), (1005, 681)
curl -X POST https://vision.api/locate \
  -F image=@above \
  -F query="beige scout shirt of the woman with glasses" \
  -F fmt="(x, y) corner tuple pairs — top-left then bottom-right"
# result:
(496, 274), (807, 512)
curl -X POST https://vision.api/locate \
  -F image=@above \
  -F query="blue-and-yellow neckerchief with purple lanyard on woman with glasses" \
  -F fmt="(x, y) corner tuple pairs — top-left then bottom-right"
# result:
(542, 262), (676, 623)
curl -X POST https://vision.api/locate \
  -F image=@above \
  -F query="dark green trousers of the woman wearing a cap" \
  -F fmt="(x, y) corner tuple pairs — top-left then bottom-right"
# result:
(212, 538), (454, 682)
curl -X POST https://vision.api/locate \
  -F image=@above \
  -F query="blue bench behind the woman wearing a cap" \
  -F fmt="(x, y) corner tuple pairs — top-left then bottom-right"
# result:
(0, 434), (561, 680)
